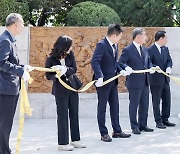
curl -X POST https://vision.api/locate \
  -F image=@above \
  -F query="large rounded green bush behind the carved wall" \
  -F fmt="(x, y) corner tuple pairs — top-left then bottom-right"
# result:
(67, 2), (120, 26)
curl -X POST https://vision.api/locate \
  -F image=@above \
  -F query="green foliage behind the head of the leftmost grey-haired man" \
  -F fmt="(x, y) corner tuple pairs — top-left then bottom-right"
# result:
(0, 0), (29, 26)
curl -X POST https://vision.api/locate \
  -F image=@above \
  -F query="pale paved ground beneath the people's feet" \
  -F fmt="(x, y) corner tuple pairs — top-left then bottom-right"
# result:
(10, 117), (180, 154)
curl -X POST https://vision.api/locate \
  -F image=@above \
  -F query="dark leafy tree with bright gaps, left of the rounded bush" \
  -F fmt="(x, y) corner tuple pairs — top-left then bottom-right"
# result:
(28, 0), (88, 26)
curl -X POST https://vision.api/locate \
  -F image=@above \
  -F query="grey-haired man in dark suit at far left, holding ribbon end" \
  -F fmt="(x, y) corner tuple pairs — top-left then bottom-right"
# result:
(0, 13), (33, 154)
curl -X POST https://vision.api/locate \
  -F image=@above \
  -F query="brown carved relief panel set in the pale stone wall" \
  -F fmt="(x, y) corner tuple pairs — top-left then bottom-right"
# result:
(29, 27), (163, 93)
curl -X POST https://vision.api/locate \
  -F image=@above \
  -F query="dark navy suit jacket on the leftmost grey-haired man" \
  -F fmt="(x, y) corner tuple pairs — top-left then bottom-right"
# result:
(0, 30), (24, 95)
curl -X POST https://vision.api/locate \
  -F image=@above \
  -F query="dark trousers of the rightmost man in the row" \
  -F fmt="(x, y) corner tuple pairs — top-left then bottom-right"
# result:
(150, 82), (171, 123)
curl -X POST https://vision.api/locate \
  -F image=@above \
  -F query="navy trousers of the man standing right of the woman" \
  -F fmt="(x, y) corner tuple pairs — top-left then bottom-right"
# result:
(96, 82), (122, 136)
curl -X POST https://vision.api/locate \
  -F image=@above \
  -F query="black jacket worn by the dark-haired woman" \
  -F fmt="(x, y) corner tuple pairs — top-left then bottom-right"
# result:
(45, 51), (77, 97)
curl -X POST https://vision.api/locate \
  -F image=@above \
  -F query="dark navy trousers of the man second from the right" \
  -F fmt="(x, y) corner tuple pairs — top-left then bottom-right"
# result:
(128, 86), (149, 129)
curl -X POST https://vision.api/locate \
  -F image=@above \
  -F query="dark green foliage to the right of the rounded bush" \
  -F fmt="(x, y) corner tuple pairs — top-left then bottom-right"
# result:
(94, 0), (176, 27)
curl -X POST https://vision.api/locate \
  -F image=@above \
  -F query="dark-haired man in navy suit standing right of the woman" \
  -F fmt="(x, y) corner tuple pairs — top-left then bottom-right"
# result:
(91, 24), (131, 142)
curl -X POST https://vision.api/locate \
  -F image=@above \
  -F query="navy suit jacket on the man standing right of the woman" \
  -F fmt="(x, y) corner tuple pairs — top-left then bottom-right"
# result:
(91, 38), (121, 84)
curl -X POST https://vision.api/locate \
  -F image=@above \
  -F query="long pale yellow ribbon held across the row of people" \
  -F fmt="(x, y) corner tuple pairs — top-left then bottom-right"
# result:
(16, 67), (180, 154)
